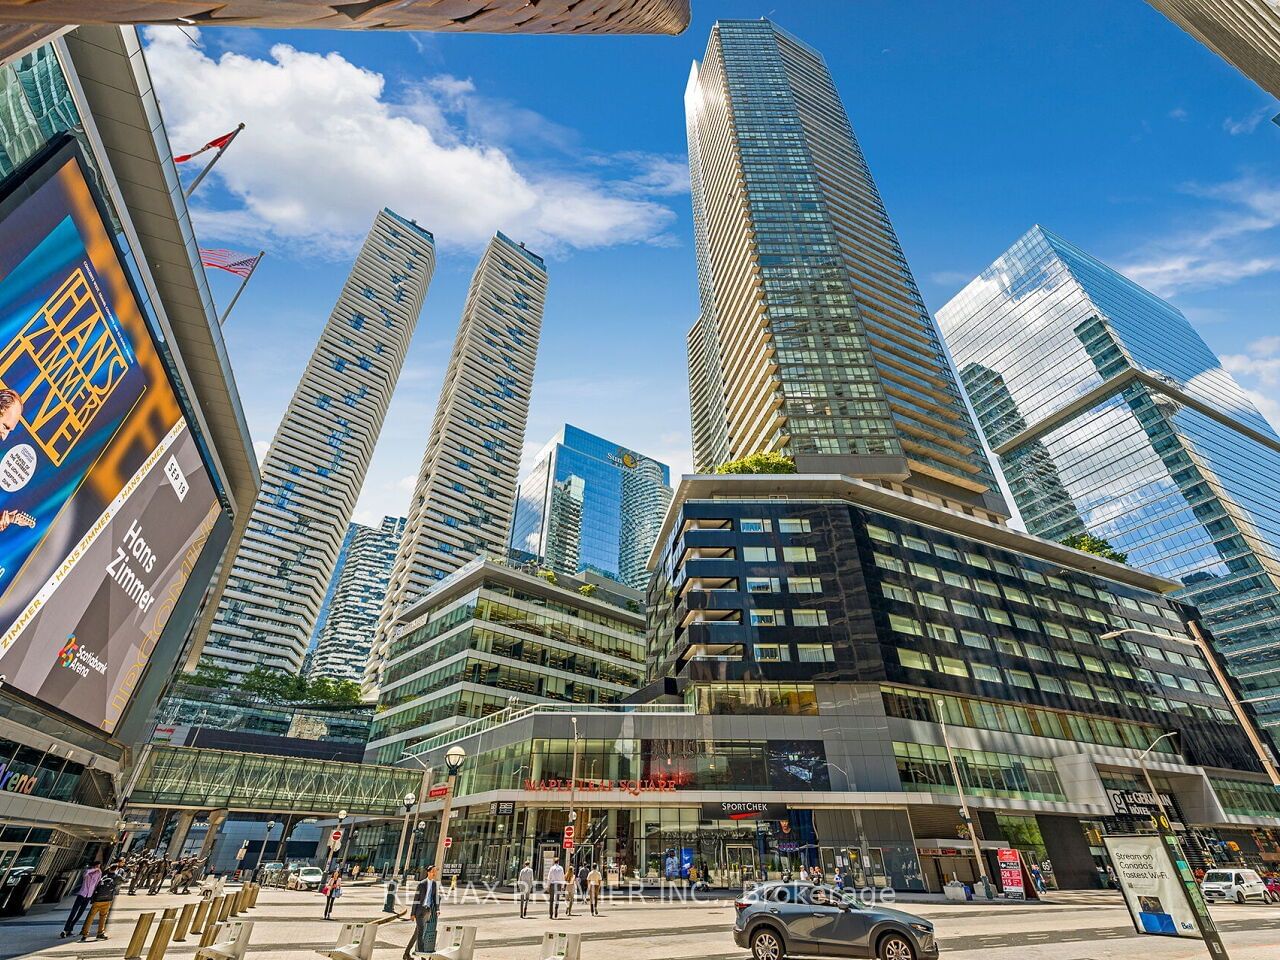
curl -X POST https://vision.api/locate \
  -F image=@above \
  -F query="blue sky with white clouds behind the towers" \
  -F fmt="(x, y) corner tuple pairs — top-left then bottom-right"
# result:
(148, 0), (1280, 522)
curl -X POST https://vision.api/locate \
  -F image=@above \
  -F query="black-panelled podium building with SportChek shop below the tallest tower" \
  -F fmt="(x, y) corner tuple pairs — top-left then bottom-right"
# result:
(388, 475), (1280, 891)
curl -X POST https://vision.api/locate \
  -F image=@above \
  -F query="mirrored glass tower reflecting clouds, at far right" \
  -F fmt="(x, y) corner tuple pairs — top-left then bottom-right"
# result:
(938, 227), (1280, 737)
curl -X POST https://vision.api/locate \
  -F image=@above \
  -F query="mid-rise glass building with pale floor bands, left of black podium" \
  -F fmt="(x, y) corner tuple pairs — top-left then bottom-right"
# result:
(366, 558), (644, 763)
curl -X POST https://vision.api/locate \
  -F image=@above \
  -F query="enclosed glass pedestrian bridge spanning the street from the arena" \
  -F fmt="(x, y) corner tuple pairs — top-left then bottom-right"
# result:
(128, 744), (422, 817)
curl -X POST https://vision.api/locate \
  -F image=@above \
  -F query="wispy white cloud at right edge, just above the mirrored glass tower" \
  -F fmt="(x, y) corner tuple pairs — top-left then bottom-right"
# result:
(1120, 177), (1280, 297)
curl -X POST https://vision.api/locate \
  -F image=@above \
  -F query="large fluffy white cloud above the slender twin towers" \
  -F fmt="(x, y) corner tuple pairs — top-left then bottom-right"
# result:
(146, 28), (675, 259)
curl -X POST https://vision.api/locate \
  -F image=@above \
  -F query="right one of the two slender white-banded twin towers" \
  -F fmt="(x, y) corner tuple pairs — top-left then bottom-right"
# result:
(365, 233), (547, 686)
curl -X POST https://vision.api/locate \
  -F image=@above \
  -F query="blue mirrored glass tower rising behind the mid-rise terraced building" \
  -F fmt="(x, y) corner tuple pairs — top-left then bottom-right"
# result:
(511, 424), (671, 591)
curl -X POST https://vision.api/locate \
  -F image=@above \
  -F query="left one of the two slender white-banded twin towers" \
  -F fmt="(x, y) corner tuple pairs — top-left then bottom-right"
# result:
(205, 210), (435, 673)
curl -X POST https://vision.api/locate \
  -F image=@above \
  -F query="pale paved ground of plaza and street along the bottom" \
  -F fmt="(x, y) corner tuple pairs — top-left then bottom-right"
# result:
(0, 886), (1280, 960)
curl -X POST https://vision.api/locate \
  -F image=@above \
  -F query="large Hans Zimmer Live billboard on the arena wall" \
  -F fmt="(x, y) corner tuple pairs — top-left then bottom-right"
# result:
(0, 141), (221, 733)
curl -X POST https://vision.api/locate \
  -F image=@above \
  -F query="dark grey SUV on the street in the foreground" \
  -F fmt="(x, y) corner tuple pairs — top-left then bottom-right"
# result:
(733, 881), (938, 960)
